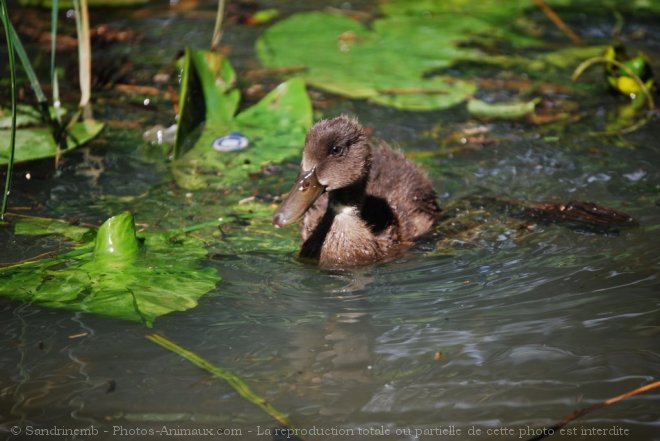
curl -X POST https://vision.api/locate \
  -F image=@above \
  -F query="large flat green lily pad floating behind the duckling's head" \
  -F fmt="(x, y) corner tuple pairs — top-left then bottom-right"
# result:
(257, 12), (494, 110)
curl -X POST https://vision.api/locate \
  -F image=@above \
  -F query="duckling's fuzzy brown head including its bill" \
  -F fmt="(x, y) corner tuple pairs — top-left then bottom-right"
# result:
(273, 116), (371, 227)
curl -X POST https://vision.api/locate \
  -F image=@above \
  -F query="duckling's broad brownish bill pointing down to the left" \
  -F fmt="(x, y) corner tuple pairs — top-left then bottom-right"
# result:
(273, 168), (325, 227)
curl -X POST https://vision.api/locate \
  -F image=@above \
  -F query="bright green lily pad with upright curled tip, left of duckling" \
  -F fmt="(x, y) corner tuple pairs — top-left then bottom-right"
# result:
(0, 212), (220, 327)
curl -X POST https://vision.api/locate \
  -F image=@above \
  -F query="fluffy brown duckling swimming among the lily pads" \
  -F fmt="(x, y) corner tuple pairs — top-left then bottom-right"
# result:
(273, 115), (441, 268)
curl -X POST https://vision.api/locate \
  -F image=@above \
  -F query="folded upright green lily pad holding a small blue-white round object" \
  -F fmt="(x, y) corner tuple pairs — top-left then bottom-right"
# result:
(172, 50), (312, 189)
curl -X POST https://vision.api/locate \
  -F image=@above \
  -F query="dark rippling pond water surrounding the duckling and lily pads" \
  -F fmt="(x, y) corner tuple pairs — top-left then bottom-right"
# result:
(0, 2), (660, 440)
